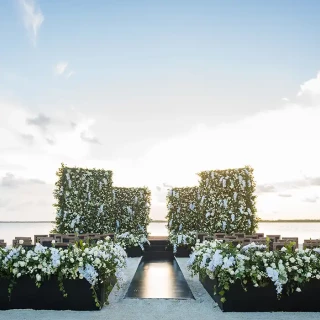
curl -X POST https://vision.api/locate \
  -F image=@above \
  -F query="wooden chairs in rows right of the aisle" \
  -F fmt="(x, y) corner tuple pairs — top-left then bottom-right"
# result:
(198, 233), (320, 250)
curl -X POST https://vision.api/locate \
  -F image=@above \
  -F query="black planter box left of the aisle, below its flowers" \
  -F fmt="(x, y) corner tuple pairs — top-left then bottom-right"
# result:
(0, 276), (116, 311)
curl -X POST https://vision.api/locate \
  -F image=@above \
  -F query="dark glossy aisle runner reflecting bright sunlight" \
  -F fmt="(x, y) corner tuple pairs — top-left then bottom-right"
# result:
(125, 258), (194, 299)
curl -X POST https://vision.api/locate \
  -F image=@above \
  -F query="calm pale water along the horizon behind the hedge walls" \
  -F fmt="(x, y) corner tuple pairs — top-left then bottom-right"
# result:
(0, 222), (320, 244)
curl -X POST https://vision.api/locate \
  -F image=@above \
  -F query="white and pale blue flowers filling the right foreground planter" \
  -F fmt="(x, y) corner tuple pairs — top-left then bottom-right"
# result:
(188, 240), (320, 302)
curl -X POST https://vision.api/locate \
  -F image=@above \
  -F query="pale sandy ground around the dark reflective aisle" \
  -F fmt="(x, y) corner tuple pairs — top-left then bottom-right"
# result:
(0, 258), (320, 320)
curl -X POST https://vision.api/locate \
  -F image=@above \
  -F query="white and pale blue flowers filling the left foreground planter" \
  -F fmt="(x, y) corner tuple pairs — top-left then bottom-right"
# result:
(0, 237), (127, 308)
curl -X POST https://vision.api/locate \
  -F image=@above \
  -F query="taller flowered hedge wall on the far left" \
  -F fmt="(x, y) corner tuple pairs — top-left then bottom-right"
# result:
(54, 164), (114, 233)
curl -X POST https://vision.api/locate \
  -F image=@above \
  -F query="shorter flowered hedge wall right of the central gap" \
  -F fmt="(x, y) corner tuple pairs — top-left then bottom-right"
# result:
(166, 187), (201, 234)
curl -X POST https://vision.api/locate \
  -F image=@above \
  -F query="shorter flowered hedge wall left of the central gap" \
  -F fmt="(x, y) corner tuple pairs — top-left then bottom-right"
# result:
(113, 187), (151, 235)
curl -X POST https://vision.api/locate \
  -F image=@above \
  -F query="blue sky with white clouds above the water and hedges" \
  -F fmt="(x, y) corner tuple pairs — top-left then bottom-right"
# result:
(0, 0), (320, 220)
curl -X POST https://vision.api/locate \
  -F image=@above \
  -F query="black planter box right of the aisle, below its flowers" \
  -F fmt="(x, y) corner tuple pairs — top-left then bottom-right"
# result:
(199, 276), (320, 312)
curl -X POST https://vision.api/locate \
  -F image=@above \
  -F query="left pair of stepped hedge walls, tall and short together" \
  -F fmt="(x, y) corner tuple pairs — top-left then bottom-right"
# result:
(54, 164), (151, 235)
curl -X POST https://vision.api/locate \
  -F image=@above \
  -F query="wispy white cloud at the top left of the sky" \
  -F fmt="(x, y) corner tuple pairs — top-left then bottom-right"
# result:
(19, 0), (44, 45)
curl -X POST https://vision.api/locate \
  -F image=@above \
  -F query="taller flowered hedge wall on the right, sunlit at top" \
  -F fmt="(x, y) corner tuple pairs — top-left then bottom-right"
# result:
(198, 166), (258, 234)
